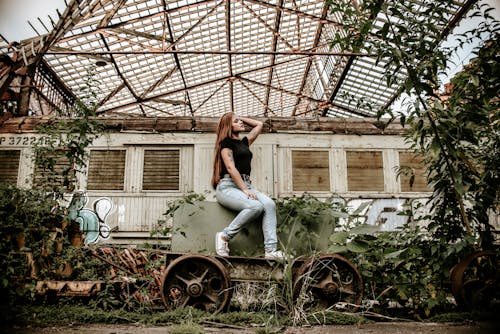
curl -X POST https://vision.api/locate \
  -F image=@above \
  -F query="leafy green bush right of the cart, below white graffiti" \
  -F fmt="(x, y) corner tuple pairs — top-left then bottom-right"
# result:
(328, 201), (477, 319)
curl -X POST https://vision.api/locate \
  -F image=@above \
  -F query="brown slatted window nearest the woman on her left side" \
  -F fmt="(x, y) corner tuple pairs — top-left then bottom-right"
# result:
(142, 149), (180, 190)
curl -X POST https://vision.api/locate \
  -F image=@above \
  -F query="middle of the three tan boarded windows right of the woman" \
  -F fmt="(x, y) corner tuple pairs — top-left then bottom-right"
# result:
(346, 151), (384, 191)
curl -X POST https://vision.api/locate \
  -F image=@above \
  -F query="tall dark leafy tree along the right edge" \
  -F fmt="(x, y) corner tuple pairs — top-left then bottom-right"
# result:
(418, 35), (500, 249)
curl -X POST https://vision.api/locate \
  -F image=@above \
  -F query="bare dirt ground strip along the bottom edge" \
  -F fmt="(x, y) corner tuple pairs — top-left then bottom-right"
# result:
(0, 322), (500, 334)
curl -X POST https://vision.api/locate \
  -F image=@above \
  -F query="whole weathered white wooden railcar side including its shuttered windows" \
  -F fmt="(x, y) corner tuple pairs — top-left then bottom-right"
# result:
(0, 118), (430, 243)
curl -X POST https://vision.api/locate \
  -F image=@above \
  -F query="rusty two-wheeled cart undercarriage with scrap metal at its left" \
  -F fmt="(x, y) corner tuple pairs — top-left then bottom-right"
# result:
(36, 247), (363, 312)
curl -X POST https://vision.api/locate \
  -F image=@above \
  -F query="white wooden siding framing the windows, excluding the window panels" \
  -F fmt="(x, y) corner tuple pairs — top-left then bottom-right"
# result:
(0, 132), (446, 240)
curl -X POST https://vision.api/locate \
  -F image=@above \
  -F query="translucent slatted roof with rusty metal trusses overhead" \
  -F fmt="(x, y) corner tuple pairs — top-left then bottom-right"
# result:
(0, 0), (472, 117)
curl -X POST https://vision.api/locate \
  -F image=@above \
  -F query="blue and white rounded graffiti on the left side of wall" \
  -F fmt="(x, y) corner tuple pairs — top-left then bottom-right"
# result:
(68, 191), (113, 245)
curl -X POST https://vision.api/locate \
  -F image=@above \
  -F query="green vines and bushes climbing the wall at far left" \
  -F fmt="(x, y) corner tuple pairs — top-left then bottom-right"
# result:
(0, 68), (103, 301)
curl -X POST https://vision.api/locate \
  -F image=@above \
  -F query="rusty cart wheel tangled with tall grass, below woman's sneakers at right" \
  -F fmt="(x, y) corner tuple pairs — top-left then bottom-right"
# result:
(293, 254), (363, 311)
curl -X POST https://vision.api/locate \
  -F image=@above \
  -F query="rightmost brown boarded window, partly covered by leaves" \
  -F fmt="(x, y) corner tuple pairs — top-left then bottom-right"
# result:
(399, 152), (431, 192)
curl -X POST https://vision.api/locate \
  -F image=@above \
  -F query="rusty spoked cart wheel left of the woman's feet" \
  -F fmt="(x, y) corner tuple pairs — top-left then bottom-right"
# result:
(161, 254), (231, 313)
